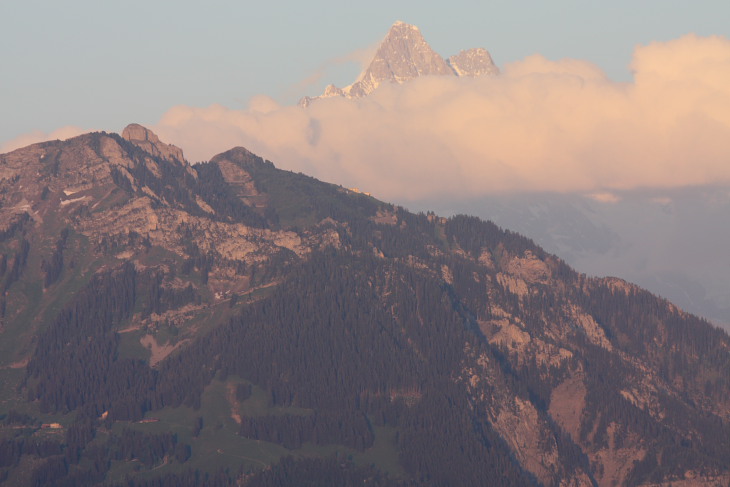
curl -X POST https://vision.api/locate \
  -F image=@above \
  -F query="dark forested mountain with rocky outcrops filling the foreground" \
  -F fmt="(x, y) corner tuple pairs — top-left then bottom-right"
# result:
(0, 125), (730, 486)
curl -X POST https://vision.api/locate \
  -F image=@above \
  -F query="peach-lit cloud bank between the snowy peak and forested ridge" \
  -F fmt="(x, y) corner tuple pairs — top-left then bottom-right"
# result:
(52, 35), (730, 201)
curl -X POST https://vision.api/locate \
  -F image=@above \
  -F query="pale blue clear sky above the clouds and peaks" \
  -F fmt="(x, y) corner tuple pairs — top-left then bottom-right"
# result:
(0, 0), (730, 146)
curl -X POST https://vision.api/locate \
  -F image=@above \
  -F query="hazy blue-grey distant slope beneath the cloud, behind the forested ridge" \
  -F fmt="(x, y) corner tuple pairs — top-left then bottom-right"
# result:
(414, 191), (730, 330)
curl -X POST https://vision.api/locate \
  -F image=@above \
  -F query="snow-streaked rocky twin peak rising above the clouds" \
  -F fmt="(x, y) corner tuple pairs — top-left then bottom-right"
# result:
(299, 21), (499, 106)
